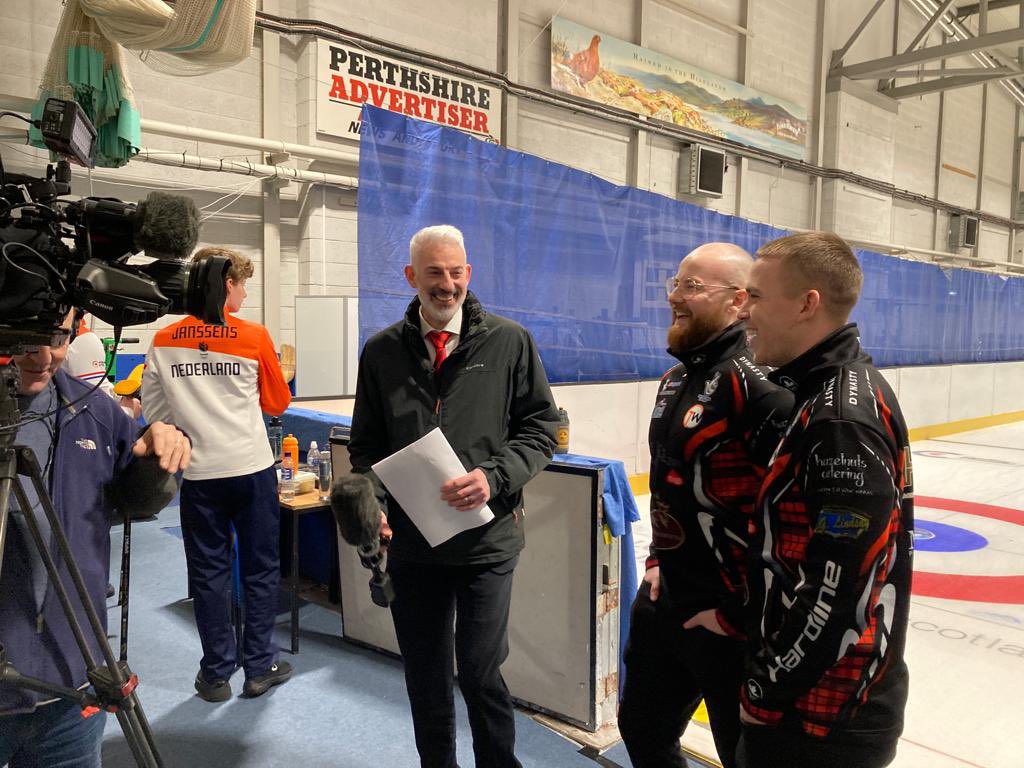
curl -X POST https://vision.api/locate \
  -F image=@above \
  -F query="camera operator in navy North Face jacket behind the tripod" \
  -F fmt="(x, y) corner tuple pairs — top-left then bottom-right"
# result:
(0, 313), (191, 768)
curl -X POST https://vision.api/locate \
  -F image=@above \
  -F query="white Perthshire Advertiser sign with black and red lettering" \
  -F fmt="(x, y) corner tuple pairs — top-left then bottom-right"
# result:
(316, 40), (502, 143)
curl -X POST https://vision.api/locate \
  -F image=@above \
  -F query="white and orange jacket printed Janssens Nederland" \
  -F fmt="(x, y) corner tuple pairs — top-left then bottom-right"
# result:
(142, 313), (292, 480)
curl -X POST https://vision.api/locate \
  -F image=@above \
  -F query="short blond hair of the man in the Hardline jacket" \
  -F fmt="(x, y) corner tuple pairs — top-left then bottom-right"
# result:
(757, 231), (864, 322)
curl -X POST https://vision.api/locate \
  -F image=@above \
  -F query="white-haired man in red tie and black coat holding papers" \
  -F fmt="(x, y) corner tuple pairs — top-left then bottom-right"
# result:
(348, 225), (558, 768)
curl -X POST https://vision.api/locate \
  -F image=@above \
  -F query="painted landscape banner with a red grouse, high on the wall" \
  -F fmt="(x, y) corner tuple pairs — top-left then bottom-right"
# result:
(551, 16), (809, 160)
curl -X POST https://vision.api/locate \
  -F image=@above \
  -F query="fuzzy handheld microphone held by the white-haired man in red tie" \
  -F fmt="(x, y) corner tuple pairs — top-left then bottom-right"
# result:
(331, 474), (394, 607)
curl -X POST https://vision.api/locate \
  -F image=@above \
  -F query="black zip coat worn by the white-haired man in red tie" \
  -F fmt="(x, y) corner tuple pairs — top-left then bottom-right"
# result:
(348, 292), (558, 564)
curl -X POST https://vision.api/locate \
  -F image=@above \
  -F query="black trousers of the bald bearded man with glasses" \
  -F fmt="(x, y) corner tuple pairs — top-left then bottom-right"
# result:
(618, 584), (743, 768)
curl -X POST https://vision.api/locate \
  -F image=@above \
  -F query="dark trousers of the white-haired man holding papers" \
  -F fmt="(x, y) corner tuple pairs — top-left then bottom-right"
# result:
(388, 557), (521, 768)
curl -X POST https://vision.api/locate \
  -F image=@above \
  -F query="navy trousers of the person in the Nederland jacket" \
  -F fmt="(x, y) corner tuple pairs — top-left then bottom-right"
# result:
(181, 467), (281, 681)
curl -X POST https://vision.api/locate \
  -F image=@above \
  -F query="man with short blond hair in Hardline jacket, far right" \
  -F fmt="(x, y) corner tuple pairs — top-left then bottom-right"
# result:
(738, 232), (913, 768)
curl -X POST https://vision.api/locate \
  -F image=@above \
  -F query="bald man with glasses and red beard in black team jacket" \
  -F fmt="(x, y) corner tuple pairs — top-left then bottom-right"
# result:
(618, 243), (793, 768)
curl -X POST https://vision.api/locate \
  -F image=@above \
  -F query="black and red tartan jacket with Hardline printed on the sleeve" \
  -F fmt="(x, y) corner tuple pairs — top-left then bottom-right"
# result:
(741, 325), (913, 744)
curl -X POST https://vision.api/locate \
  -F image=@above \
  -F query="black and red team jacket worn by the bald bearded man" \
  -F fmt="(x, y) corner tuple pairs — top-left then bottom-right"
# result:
(647, 323), (793, 637)
